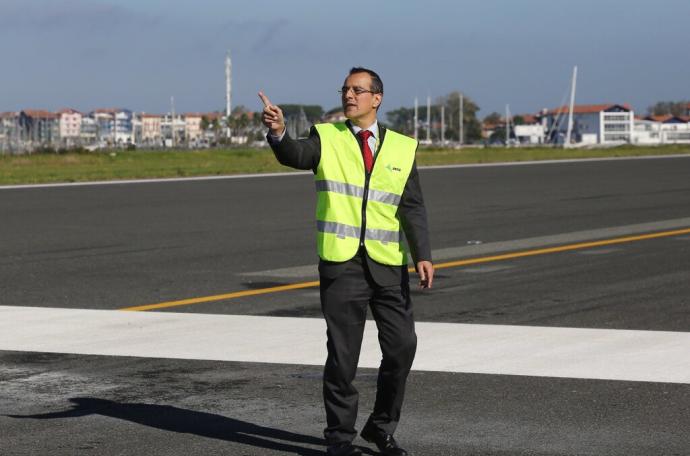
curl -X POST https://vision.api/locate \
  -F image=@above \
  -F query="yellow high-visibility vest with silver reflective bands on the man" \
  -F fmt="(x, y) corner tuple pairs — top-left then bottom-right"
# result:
(315, 123), (417, 266)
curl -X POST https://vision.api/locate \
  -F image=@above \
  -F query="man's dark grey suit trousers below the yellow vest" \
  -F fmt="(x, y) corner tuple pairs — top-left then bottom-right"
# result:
(321, 251), (417, 445)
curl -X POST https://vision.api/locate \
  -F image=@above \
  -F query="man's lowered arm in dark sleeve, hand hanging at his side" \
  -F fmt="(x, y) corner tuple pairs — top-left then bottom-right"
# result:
(398, 162), (434, 288)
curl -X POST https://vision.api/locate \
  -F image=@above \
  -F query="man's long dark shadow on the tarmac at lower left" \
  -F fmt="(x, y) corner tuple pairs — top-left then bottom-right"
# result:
(6, 397), (376, 456)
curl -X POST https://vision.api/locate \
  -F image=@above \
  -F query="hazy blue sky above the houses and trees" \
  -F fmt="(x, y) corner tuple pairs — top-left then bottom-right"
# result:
(0, 0), (690, 116)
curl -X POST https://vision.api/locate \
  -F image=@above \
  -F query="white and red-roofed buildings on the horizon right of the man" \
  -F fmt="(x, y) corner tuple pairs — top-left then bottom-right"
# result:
(490, 103), (690, 146)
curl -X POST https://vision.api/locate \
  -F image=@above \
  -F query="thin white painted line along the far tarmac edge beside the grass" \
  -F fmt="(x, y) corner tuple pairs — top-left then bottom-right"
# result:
(0, 155), (690, 190)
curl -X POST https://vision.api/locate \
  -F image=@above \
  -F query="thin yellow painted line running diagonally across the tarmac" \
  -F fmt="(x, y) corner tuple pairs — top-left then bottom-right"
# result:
(120, 228), (690, 311)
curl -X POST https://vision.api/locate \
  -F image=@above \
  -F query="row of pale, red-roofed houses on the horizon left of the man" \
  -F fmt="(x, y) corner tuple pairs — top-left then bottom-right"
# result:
(0, 109), (247, 151)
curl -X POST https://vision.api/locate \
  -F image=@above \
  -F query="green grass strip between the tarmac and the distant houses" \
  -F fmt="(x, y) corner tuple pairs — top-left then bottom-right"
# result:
(0, 145), (690, 185)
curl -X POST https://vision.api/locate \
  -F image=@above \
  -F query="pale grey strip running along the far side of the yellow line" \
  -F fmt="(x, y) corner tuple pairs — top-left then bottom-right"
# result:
(241, 217), (690, 279)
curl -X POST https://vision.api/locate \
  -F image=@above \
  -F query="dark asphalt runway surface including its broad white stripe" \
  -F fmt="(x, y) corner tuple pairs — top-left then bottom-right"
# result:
(0, 157), (690, 456)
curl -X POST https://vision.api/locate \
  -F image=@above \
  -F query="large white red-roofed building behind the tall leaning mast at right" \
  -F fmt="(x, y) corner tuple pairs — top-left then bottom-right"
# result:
(544, 103), (635, 144)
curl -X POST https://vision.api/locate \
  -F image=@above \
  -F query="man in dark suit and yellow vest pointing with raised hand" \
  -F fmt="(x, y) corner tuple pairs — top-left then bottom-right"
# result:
(259, 67), (434, 456)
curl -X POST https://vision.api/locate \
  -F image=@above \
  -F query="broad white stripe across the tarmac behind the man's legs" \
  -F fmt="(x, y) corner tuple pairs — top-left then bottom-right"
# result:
(0, 306), (690, 384)
